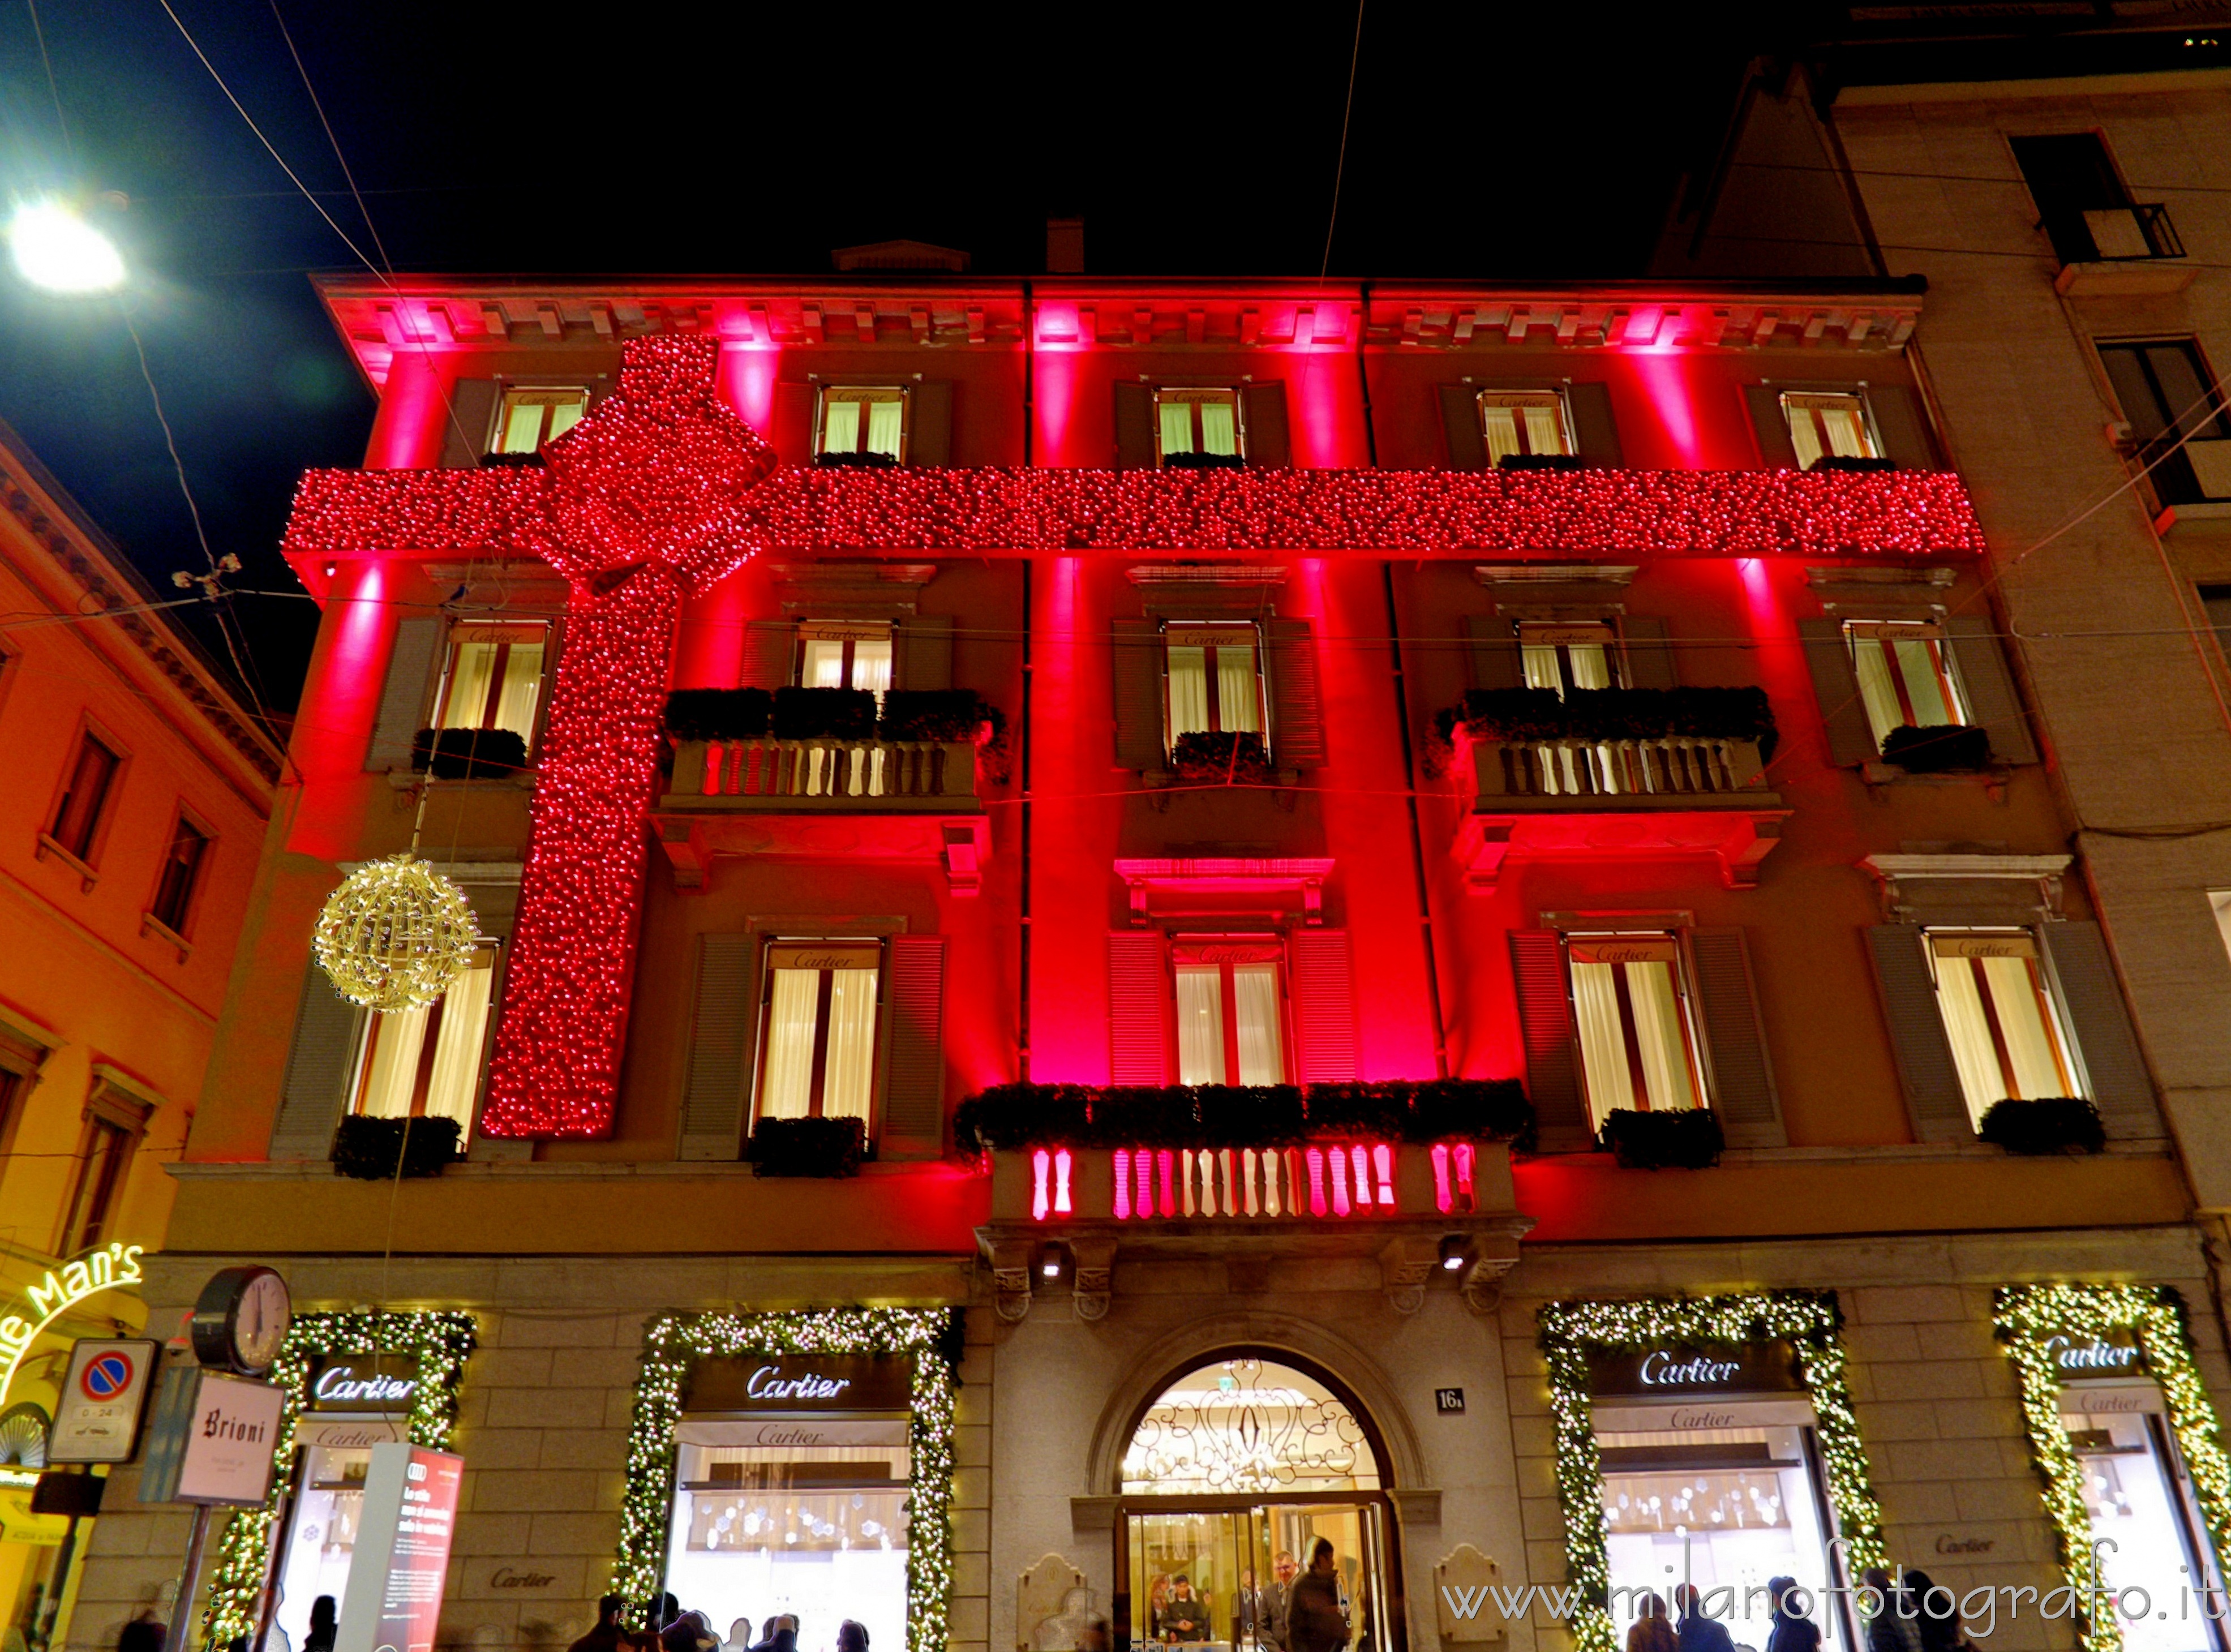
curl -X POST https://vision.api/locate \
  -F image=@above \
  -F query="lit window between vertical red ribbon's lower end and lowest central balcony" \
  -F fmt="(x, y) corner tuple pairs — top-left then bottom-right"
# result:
(758, 940), (883, 1121)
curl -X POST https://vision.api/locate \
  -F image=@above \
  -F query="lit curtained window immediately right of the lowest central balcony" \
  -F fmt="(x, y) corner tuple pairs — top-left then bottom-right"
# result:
(1564, 931), (1705, 1130)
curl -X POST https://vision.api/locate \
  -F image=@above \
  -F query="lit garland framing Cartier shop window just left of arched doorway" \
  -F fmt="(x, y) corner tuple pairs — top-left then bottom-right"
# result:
(609, 1308), (953, 1652)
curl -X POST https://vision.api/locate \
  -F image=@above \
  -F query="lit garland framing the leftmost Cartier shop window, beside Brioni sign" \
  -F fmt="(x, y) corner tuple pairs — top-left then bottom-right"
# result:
(201, 1312), (478, 1645)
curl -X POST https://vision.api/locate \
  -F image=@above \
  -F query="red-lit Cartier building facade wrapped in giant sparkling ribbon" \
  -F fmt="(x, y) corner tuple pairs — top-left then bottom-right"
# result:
(57, 261), (2226, 1652)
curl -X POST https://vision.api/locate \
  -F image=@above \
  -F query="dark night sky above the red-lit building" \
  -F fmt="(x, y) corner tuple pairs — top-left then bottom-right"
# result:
(0, 0), (1753, 710)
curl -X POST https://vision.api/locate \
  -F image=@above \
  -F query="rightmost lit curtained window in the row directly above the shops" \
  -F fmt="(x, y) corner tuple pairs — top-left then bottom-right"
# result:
(1928, 929), (2084, 1125)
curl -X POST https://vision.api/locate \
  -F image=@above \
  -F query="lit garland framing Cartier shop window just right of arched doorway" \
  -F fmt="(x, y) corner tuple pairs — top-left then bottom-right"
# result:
(1539, 1290), (1887, 1652)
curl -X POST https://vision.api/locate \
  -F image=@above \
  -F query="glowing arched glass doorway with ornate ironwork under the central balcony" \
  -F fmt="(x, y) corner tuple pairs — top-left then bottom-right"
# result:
(1113, 1349), (1404, 1652)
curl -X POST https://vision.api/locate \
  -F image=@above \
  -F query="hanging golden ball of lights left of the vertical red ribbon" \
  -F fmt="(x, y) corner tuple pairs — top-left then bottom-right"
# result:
(315, 851), (480, 1014)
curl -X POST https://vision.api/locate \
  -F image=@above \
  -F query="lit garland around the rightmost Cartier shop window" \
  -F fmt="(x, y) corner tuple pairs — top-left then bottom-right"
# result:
(1992, 1286), (2231, 1652)
